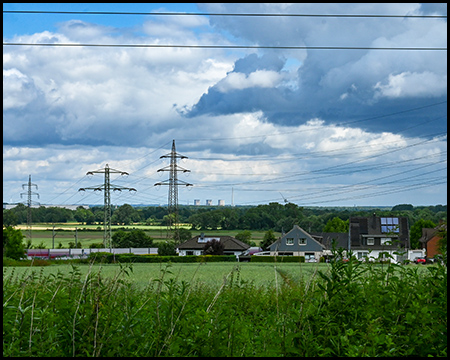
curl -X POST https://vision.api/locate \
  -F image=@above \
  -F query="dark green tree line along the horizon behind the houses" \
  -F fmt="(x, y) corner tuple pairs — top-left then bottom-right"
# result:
(3, 203), (447, 232)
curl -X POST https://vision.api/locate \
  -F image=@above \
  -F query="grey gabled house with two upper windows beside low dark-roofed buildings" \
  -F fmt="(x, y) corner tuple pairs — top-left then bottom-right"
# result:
(269, 225), (326, 262)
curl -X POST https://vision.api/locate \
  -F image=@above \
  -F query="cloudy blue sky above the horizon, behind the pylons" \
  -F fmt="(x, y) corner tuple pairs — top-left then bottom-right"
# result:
(3, 3), (447, 207)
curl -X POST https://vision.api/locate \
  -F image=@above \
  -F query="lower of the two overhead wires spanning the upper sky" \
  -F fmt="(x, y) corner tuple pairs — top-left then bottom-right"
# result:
(3, 43), (447, 51)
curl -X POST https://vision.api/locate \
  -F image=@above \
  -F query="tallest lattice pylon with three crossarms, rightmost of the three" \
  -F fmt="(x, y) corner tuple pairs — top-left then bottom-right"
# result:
(155, 140), (193, 241)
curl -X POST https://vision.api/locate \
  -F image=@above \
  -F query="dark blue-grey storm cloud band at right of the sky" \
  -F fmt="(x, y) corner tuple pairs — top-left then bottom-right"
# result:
(185, 54), (446, 136)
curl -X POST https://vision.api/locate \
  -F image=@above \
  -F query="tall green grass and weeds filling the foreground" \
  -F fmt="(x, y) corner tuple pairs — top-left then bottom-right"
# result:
(3, 252), (447, 357)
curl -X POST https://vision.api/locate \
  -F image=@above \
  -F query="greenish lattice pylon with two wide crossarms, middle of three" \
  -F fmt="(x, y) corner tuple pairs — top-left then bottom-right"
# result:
(78, 164), (136, 248)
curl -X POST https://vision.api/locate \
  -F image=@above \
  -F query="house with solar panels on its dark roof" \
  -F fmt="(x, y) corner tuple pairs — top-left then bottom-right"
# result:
(348, 214), (410, 262)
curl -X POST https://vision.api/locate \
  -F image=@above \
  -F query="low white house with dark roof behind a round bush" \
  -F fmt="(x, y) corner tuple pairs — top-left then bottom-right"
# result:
(177, 234), (250, 256)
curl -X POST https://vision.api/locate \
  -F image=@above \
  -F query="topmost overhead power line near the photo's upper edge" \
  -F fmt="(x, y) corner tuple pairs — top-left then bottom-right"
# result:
(3, 10), (447, 19)
